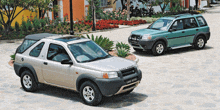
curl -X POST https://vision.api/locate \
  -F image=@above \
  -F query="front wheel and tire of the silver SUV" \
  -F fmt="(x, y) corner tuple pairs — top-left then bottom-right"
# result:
(80, 81), (102, 106)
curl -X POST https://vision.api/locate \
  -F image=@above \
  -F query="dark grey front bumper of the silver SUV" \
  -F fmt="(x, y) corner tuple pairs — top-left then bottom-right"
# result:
(96, 70), (142, 96)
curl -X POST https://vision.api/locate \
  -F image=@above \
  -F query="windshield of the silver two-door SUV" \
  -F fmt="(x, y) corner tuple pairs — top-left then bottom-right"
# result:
(68, 41), (109, 63)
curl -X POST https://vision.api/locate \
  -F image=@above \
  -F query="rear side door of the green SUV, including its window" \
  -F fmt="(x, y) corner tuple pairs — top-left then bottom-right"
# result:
(184, 18), (199, 44)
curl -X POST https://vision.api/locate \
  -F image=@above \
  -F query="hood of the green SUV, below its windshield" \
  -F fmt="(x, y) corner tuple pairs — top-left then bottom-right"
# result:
(131, 29), (165, 35)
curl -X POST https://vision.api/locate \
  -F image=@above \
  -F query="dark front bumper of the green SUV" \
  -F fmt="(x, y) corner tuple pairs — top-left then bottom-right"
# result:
(128, 39), (155, 50)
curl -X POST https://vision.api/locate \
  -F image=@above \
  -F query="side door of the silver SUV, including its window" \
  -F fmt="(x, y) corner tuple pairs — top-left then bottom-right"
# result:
(43, 43), (75, 88)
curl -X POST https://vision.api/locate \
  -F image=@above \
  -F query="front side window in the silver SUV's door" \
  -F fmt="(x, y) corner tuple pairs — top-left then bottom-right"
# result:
(47, 44), (70, 62)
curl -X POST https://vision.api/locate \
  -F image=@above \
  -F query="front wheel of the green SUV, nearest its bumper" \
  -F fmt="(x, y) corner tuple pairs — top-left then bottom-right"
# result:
(152, 41), (165, 56)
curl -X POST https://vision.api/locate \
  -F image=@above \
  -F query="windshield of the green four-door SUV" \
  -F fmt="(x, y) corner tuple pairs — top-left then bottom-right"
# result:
(148, 19), (172, 31)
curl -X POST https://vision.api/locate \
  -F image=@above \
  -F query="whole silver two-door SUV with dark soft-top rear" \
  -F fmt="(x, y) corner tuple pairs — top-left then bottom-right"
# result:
(14, 33), (142, 105)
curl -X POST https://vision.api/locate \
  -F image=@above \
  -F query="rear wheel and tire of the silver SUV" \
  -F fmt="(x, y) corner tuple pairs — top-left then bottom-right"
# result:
(21, 70), (38, 92)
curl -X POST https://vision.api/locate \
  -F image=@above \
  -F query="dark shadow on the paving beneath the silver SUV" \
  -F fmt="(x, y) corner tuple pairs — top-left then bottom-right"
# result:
(20, 84), (148, 108)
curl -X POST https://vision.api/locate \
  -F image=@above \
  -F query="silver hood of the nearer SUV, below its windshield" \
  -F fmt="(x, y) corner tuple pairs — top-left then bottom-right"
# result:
(79, 57), (136, 72)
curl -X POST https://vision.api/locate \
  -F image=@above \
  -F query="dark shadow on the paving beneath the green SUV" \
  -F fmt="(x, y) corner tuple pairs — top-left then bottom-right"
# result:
(133, 46), (213, 57)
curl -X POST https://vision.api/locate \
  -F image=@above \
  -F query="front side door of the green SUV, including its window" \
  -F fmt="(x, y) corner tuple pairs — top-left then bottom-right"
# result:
(166, 20), (186, 47)
